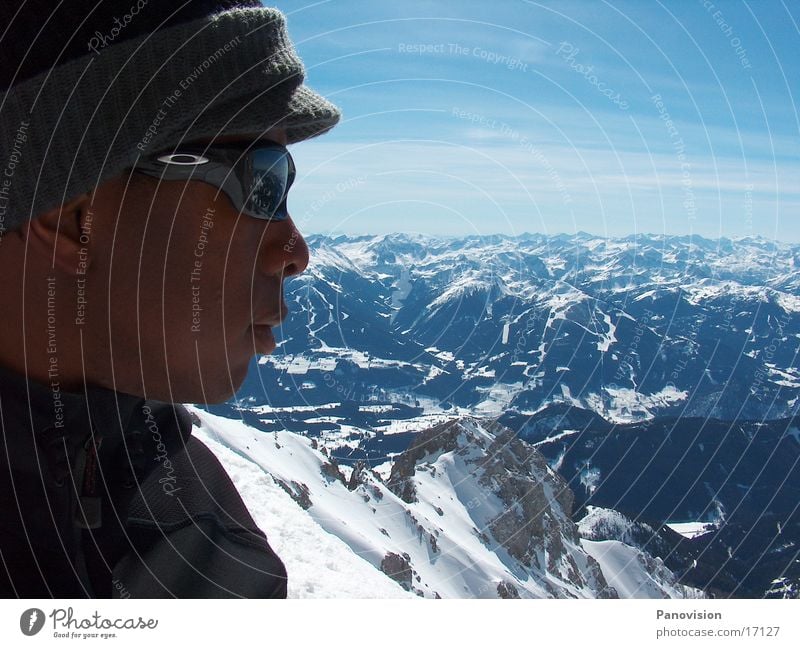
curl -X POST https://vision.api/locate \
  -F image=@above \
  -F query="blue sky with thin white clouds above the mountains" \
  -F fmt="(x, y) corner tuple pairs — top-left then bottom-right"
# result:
(270, 0), (800, 242)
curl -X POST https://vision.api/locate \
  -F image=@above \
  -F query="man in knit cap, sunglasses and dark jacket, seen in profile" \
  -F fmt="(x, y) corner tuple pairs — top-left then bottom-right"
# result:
(0, 0), (339, 598)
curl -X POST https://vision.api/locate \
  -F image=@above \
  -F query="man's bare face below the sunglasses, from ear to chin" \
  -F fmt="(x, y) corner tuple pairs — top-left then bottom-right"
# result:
(87, 129), (308, 402)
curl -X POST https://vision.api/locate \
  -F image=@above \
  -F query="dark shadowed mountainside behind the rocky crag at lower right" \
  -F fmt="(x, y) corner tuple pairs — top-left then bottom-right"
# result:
(506, 404), (800, 597)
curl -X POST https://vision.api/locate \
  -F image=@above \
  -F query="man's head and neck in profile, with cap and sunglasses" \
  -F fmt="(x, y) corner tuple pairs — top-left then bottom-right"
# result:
(0, 0), (338, 402)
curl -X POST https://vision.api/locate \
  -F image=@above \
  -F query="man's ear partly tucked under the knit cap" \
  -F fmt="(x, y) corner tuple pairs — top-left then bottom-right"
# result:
(27, 194), (91, 275)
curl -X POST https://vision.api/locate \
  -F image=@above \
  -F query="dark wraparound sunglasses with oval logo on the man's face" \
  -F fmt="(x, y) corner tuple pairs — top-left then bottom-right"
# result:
(133, 142), (295, 221)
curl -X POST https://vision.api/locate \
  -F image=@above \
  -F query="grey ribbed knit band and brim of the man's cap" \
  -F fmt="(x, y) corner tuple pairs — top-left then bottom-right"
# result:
(0, 8), (340, 236)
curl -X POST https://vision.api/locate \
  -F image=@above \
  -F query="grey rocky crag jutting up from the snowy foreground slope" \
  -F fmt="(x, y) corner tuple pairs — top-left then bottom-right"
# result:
(388, 417), (616, 598)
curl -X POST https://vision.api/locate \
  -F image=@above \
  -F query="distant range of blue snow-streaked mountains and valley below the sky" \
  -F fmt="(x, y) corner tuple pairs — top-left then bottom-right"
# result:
(241, 234), (800, 432)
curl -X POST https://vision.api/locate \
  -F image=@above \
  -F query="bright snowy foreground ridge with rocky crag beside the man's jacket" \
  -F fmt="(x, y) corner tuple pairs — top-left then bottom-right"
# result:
(191, 408), (702, 598)
